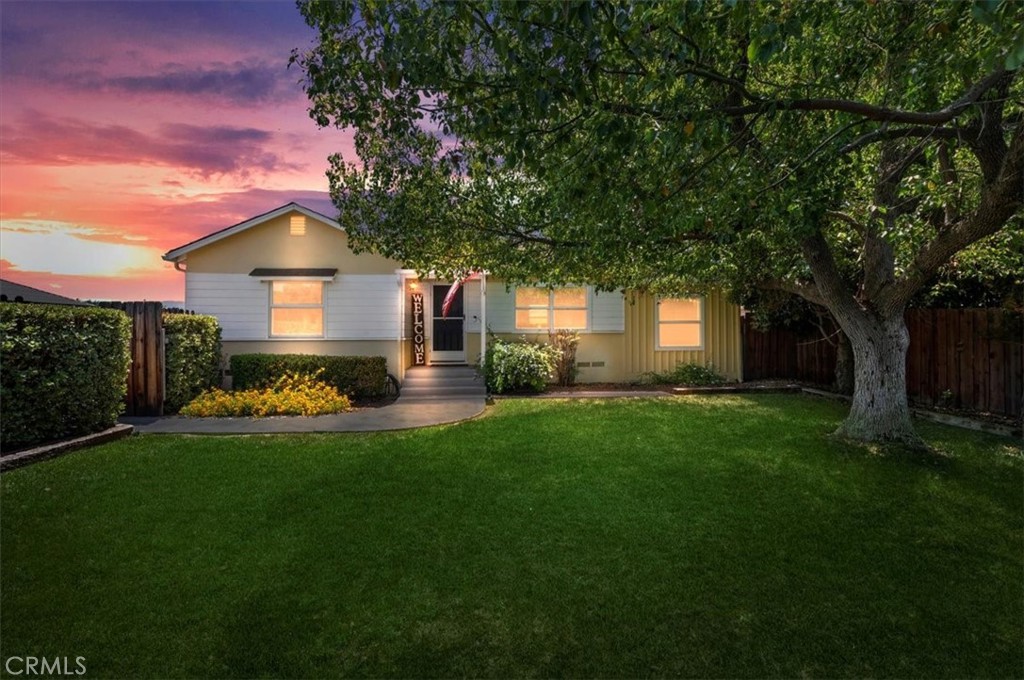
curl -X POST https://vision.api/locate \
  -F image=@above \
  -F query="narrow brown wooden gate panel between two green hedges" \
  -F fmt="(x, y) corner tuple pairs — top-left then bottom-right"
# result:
(117, 302), (165, 416)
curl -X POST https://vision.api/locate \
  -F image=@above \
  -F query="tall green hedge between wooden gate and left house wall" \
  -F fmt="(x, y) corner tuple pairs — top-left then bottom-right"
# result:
(164, 313), (220, 414)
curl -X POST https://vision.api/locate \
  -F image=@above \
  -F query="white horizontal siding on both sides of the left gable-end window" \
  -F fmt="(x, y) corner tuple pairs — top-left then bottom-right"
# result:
(185, 272), (399, 341)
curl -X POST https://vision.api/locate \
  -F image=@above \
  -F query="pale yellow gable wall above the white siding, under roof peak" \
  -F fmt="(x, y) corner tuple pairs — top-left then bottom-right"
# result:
(185, 211), (401, 274)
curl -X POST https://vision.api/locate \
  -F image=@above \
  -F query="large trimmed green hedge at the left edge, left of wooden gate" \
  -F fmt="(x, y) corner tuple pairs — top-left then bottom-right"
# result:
(0, 303), (131, 449)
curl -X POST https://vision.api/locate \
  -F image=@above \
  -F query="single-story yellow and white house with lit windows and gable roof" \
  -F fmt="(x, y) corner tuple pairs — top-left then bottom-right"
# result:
(164, 203), (741, 382)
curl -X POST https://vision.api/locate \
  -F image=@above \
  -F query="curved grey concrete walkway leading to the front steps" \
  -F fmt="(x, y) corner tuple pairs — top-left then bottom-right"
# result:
(119, 396), (484, 434)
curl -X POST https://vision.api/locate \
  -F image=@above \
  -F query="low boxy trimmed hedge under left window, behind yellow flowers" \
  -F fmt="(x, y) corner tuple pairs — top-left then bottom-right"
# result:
(231, 354), (387, 399)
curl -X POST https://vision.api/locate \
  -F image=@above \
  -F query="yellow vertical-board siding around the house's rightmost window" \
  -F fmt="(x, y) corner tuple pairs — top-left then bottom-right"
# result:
(625, 291), (741, 380)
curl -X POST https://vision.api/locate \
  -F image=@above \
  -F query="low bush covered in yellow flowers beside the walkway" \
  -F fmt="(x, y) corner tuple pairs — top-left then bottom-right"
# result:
(181, 371), (352, 418)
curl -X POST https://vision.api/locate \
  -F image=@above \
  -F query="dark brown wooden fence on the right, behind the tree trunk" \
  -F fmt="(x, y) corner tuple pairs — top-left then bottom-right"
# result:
(742, 309), (1024, 418)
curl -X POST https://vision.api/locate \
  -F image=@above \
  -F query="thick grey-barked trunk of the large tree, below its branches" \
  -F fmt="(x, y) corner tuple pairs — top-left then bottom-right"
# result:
(837, 311), (926, 449)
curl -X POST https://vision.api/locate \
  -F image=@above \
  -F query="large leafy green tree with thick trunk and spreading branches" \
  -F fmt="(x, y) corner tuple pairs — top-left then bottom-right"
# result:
(294, 0), (1024, 444)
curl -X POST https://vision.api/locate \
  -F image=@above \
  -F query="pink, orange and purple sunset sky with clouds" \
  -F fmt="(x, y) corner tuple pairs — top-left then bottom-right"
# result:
(0, 1), (351, 301)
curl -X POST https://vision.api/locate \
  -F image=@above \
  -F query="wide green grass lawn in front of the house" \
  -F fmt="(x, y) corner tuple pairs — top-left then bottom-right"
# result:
(0, 395), (1024, 677)
